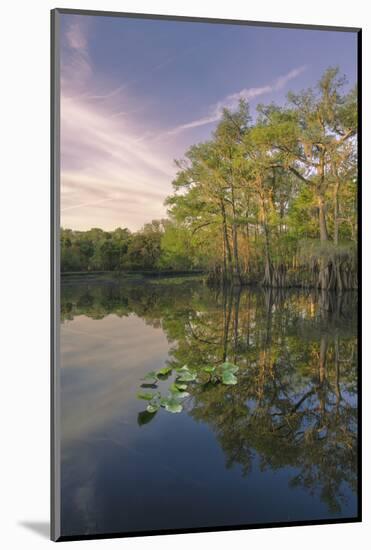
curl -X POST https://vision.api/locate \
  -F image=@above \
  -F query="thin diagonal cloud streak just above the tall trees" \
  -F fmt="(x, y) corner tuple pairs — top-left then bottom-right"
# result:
(167, 65), (306, 135)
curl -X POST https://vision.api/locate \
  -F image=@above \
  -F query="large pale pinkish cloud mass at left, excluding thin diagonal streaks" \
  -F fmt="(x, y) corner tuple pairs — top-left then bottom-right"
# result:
(61, 18), (175, 229)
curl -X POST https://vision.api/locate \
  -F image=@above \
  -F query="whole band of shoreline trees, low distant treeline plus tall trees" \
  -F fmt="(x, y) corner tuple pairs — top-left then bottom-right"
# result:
(61, 68), (358, 292)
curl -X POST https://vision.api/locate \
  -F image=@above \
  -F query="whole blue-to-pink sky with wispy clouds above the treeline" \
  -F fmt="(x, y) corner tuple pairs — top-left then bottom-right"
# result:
(60, 14), (357, 231)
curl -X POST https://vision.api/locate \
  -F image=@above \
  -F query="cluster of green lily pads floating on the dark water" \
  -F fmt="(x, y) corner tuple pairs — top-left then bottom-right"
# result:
(137, 363), (238, 425)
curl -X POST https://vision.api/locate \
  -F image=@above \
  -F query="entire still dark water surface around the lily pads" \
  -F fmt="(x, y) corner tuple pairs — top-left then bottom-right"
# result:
(61, 279), (357, 535)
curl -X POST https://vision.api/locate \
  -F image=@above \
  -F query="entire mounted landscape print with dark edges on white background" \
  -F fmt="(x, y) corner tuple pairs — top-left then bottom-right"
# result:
(52, 9), (361, 540)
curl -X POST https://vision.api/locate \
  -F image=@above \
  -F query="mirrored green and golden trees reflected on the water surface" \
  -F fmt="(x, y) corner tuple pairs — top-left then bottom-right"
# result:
(62, 280), (357, 512)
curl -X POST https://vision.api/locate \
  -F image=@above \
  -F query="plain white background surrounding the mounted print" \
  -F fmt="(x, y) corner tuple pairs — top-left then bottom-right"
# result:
(0, 0), (371, 550)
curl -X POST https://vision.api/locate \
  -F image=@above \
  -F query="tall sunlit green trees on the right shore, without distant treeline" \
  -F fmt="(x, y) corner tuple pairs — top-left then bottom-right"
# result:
(167, 68), (357, 288)
